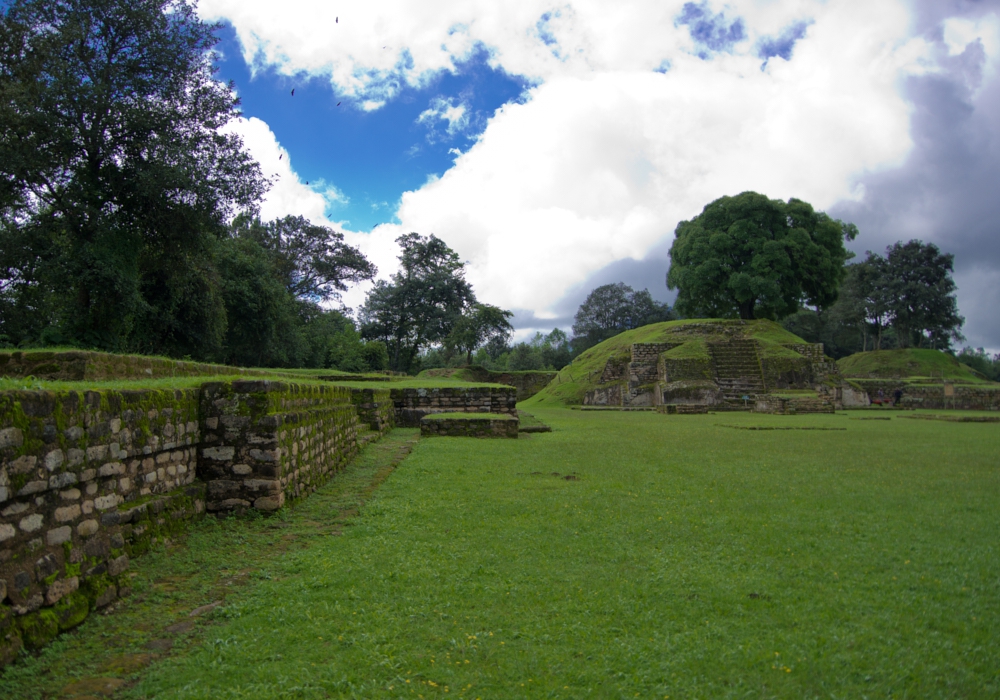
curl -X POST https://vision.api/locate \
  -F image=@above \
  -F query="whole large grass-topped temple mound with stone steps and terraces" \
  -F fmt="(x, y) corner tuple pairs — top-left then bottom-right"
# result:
(532, 319), (867, 413)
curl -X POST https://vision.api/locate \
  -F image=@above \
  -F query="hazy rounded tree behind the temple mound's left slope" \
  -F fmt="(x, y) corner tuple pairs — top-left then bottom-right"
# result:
(573, 282), (676, 351)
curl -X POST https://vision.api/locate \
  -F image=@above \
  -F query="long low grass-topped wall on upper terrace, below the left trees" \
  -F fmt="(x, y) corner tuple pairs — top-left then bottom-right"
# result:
(0, 350), (273, 381)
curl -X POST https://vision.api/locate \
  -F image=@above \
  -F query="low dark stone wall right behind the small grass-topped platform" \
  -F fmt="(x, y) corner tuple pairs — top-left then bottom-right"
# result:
(389, 386), (517, 428)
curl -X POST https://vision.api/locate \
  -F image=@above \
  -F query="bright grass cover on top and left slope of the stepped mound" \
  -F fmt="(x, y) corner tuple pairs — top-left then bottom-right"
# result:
(528, 319), (806, 405)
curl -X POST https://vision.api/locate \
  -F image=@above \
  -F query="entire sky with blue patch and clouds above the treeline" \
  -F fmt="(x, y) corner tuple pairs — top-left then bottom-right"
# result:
(199, 0), (1000, 352)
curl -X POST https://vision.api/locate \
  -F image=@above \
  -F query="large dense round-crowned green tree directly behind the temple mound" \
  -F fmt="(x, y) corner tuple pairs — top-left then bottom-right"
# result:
(667, 192), (857, 319)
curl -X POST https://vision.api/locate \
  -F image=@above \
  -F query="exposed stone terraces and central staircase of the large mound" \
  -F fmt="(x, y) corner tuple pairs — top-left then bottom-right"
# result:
(584, 321), (867, 413)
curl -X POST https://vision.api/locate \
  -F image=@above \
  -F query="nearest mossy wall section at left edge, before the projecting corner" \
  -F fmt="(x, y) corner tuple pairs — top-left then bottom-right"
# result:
(0, 389), (204, 664)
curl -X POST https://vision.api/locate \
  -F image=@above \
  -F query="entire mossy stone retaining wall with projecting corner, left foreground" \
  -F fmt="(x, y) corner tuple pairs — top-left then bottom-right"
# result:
(0, 380), (394, 665)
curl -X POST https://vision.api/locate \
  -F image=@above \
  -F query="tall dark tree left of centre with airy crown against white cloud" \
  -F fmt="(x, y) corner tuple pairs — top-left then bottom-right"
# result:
(360, 233), (476, 372)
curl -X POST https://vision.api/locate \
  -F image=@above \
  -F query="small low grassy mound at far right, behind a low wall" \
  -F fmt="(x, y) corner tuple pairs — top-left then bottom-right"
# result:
(837, 348), (986, 384)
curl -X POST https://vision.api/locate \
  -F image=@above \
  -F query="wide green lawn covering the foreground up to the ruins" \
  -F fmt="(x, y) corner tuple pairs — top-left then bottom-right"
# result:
(0, 405), (1000, 700)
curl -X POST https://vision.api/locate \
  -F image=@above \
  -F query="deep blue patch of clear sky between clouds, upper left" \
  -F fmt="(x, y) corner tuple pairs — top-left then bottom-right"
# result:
(217, 23), (528, 231)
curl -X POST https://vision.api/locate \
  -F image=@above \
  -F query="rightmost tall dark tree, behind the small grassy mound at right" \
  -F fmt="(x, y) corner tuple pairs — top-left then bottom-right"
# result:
(884, 240), (965, 348)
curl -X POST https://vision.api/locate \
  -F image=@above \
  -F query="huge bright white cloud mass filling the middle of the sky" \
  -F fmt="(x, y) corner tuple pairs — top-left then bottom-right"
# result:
(211, 0), (944, 318)
